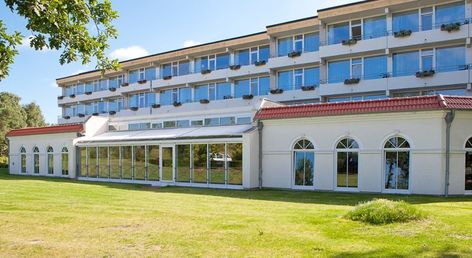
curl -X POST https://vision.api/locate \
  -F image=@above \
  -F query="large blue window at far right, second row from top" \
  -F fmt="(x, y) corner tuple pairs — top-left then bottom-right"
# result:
(436, 46), (465, 72)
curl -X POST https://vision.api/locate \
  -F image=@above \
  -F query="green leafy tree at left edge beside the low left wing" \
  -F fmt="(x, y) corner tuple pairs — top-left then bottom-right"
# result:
(0, 92), (26, 157)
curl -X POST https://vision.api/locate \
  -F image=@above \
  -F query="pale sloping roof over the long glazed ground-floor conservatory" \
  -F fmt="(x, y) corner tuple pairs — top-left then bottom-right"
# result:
(77, 125), (253, 145)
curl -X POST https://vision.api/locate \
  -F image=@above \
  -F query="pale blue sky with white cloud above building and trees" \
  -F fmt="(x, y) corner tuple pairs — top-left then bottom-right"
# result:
(0, 0), (355, 123)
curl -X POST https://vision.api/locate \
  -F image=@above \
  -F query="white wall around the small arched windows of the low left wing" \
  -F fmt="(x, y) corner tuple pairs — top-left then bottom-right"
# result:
(9, 133), (77, 178)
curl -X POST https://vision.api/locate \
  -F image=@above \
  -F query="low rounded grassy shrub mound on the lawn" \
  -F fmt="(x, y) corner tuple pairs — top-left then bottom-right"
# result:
(345, 199), (425, 224)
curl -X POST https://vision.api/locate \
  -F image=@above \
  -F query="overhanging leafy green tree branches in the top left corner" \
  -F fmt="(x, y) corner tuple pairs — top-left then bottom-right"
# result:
(0, 0), (119, 80)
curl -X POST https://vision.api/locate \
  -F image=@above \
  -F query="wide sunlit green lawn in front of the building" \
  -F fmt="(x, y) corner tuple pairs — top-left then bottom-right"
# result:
(0, 170), (472, 257)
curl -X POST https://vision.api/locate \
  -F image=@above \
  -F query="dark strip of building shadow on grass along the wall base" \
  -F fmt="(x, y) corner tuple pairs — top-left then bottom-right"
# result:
(0, 170), (472, 206)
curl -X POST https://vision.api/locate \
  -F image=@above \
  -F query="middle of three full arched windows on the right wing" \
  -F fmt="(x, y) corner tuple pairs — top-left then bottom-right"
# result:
(336, 138), (359, 188)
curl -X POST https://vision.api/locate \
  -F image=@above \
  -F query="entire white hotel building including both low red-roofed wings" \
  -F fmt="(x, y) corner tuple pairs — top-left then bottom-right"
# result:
(8, 0), (472, 195)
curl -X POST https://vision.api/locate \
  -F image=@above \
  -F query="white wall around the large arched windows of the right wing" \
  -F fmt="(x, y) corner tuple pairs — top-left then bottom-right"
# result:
(263, 111), (472, 194)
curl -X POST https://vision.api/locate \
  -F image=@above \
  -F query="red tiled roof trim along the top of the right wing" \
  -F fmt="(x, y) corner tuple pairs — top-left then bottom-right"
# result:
(254, 95), (472, 120)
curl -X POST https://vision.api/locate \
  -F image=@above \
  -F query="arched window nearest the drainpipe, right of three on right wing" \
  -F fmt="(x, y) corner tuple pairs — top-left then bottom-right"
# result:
(384, 136), (410, 190)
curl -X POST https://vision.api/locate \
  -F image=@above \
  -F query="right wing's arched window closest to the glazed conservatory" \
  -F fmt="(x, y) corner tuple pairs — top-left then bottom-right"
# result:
(293, 139), (315, 186)
